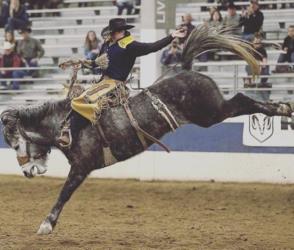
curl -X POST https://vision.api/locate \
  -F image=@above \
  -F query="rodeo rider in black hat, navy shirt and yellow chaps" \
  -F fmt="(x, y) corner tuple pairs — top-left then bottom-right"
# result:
(59, 18), (186, 147)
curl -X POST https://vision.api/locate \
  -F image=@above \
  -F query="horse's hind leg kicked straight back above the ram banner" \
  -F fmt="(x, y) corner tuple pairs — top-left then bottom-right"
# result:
(222, 93), (293, 120)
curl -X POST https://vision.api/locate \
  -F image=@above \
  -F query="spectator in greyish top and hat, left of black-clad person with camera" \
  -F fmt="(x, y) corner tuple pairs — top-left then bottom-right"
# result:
(223, 3), (242, 36)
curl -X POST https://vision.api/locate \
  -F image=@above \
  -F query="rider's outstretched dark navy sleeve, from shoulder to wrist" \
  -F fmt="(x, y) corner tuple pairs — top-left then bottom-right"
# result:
(127, 35), (174, 57)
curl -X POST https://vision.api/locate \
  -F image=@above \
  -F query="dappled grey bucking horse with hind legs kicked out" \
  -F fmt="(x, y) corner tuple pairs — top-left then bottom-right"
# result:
(1, 27), (292, 234)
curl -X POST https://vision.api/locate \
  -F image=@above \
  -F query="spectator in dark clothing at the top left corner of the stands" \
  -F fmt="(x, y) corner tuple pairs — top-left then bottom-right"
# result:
(5, 0), (29, 31)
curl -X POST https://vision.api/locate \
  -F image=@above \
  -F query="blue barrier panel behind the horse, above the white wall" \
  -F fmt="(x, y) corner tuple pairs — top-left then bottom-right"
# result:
(0, 123), (294, 154)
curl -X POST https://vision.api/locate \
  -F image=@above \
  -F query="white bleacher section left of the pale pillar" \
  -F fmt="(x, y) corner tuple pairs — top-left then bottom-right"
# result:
(0, 0), (140, 106)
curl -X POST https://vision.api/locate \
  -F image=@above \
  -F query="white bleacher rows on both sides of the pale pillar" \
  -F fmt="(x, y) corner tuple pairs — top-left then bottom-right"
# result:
(0, 0), (294, 106)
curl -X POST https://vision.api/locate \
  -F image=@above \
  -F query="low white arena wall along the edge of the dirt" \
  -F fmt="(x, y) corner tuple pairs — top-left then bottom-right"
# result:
(0, 149), (294, 183)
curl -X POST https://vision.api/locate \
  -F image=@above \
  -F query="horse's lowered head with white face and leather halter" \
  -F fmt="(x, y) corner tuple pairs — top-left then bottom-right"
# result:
(0, 109), (50, 178)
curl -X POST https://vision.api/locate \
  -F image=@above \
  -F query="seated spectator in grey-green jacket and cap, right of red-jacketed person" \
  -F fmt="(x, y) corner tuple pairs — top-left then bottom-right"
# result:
(17, 28), (44, 73)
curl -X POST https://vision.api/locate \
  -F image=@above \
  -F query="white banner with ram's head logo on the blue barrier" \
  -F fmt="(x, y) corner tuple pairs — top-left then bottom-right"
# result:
(243, 114), (294, 147)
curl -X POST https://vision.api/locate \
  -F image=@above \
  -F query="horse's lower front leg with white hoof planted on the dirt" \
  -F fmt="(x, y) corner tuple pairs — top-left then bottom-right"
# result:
(37, 168), (89, 234)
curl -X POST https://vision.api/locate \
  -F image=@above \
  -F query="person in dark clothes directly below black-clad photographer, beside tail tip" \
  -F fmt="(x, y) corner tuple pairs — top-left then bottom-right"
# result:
(244, 34), (271, 101)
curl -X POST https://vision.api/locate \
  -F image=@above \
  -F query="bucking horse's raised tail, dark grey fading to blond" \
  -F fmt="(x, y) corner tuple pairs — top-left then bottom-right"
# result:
(182, 25), (259, 75)
